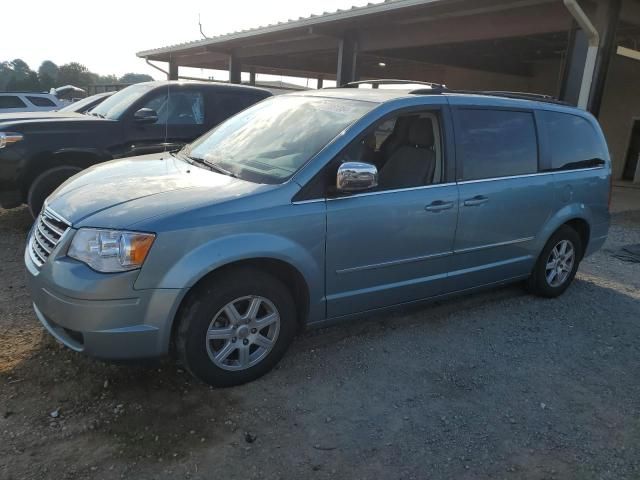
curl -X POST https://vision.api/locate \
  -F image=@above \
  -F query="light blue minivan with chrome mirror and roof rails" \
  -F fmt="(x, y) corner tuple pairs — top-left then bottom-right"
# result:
(24, 80), (611, 386)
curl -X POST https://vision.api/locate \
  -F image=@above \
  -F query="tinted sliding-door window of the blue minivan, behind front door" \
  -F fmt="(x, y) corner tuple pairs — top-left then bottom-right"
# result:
(457, 109), (538, 180)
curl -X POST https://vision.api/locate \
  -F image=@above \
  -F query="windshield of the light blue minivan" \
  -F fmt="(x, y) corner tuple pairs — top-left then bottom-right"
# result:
(184, 95), (376, 184)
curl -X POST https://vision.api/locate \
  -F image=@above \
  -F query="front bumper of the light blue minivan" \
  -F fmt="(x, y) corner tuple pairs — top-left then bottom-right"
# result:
(24, 232), (183, 360)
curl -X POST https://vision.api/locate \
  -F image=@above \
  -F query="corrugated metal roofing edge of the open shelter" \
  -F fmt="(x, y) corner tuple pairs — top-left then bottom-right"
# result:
(137, 0), (447, 57)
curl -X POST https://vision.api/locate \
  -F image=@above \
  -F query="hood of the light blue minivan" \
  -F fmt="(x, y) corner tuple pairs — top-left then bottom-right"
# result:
(47, 153), (269, 228)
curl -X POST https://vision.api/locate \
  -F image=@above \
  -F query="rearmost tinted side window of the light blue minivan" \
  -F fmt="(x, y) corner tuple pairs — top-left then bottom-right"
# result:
(542, 112), (606, 170)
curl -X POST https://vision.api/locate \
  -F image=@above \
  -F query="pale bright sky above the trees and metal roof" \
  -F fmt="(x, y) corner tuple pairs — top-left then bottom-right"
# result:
(0, 0), (375, 80)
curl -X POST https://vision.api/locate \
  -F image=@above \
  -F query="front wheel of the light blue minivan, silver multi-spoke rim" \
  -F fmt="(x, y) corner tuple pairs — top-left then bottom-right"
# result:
(176, 268), (297, 387)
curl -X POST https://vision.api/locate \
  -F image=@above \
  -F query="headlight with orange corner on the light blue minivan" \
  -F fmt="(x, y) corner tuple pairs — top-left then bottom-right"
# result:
(67, 228), (156, 273)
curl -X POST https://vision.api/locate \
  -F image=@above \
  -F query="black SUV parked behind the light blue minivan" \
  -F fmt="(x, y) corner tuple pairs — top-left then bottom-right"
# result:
(0, 81), (271, 216)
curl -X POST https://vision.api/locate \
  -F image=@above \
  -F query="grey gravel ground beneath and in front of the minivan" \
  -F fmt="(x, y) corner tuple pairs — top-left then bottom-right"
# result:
(0, 204), (640, 480)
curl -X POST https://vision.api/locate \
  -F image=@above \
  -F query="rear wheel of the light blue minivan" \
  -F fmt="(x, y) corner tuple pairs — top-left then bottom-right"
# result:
(528, 225), (582, 298)
